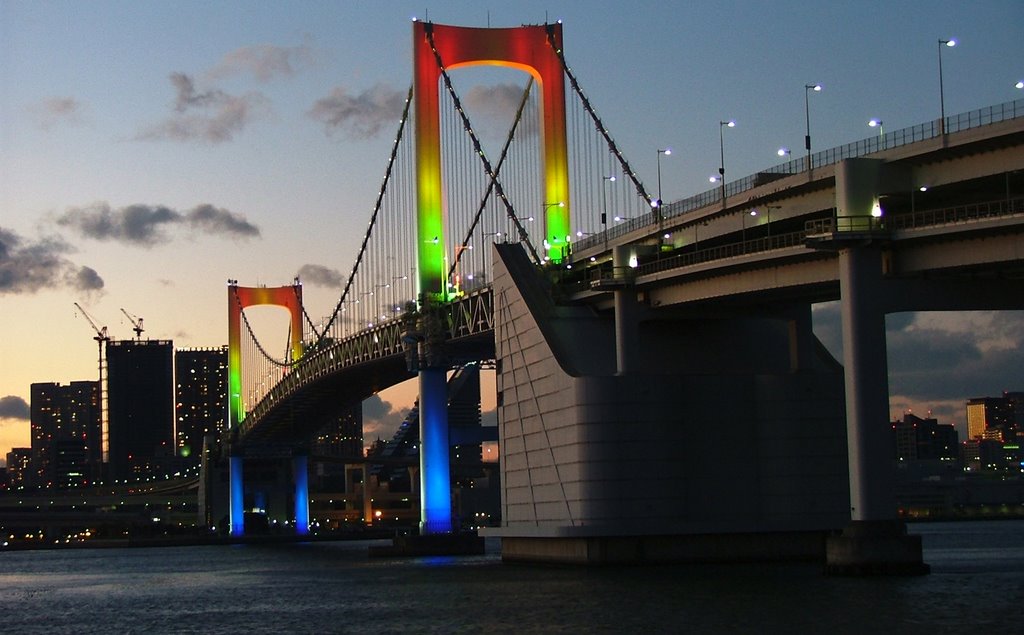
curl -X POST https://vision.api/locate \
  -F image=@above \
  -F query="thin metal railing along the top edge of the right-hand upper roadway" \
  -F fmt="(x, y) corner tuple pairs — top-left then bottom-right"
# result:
(575, 99), (1024, 251)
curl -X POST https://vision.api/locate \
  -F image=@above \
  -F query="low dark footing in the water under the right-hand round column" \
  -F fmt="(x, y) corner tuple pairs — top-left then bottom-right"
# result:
(825, 520), (931, 576)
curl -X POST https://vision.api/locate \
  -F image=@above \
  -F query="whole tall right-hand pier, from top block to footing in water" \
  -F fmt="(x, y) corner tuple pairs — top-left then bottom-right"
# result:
(825, 160), (929, 575)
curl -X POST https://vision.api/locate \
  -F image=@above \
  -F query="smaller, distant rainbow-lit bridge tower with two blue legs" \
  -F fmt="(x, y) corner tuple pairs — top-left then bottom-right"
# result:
(227, 280), (309, 536)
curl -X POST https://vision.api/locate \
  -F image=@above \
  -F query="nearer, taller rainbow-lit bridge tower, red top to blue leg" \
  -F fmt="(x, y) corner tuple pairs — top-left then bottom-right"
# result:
(413, 22), (570, 535)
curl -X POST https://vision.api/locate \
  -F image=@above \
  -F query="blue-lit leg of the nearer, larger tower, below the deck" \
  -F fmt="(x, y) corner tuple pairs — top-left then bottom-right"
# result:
(420, 368), (452, 535)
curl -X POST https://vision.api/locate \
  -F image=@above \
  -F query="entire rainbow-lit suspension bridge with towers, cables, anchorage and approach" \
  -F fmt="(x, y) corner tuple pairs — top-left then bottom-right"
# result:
(218, 23), (1024, 569)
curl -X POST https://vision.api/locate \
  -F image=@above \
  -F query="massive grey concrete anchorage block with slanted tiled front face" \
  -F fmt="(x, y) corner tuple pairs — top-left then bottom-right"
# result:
(480, 245), (850, 564)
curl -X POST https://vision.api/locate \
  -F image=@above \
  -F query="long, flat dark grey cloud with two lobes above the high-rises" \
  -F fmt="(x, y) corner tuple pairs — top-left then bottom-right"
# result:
(56, 203), (260, 247)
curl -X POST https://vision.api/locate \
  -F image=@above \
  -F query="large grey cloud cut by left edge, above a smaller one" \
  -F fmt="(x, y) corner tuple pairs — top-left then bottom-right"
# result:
(0, 227), (103, 295)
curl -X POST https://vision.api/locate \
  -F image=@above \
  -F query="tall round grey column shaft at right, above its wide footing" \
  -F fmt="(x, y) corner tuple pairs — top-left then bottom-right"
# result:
(839, 245), (896, 521)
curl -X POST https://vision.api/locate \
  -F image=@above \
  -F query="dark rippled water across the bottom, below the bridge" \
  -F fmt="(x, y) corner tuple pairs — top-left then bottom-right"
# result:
(0, 520), (1024, 635)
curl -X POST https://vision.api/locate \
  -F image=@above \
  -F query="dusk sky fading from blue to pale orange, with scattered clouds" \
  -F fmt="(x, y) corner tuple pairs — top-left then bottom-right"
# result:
(0, 0), (1024, 462)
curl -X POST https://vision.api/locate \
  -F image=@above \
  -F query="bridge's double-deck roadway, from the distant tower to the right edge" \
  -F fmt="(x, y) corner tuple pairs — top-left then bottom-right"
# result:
(236, 108), (1024, 448)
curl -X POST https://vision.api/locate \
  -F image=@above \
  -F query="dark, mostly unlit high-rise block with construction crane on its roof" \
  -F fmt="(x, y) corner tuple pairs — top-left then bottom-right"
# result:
(106, 340), (174, 479)
